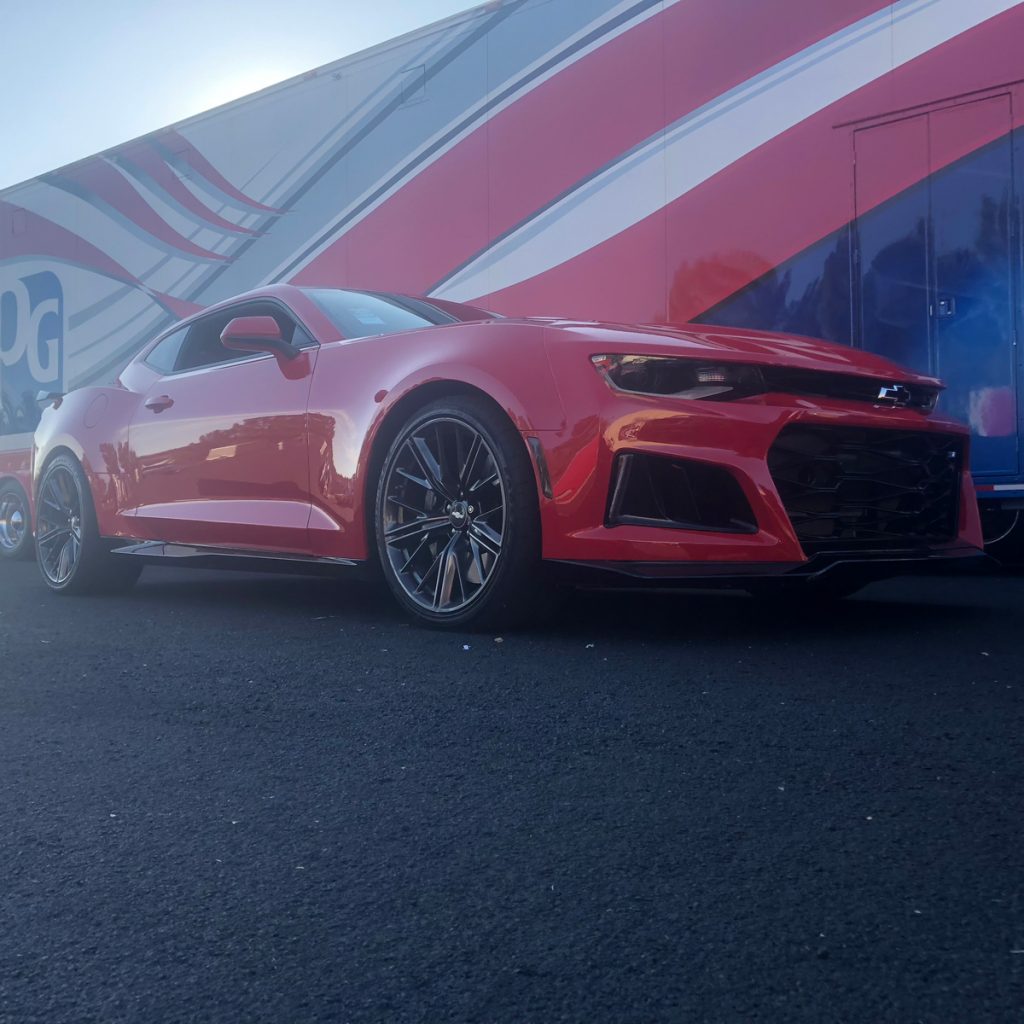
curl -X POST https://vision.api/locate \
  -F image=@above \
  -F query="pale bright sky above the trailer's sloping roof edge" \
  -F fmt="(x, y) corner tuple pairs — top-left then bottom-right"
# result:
(0, 0), (471, 188)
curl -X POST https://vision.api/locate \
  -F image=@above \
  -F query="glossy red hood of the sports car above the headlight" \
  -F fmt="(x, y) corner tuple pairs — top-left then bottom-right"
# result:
(530, 319), (942, 388)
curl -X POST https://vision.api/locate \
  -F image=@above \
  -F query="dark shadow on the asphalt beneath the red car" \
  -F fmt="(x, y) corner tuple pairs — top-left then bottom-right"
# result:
(123, 569), (1024, 642)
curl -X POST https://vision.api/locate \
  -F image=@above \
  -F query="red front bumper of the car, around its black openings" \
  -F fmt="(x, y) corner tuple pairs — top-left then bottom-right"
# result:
(542, 389), (982, 573)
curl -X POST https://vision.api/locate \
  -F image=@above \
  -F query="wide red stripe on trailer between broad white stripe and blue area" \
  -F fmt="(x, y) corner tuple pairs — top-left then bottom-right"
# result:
(481, 7), (1024, 322)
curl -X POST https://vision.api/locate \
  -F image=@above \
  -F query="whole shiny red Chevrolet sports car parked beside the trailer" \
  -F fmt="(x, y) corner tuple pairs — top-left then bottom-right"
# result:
(33, 286), (982, 627)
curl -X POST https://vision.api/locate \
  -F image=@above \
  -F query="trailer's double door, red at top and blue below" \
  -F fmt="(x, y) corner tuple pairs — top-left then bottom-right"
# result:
(854, 95), (1020, 477)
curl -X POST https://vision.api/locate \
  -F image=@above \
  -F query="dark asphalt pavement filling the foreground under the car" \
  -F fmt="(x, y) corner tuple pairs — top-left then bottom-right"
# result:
(0, 564), (1024, 1024)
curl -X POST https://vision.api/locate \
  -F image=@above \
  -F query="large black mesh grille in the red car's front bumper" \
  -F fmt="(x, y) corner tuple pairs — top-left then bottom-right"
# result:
(768, 426), (964, 555)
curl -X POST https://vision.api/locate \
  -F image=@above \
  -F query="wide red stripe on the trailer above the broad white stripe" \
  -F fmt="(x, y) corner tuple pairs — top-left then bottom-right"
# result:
(294, 0), (888, 293)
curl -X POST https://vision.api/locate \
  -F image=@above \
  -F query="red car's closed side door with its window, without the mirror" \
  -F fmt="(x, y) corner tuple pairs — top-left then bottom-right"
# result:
(129, 301), (317, 554)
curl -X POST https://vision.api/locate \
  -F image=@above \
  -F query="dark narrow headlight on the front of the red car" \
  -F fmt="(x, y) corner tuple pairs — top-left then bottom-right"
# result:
(591, 355), (765, 401)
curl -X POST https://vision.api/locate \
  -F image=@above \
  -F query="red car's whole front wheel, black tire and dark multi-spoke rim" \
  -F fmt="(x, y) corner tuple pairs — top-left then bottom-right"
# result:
(374, 395), (543, 630)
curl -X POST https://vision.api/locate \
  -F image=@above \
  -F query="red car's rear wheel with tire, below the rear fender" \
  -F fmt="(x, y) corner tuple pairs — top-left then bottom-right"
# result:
(36, 455), (142, 594)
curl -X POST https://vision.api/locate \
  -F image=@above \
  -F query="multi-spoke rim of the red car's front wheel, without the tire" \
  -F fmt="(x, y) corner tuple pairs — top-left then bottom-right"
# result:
(379, 416), (506, 615)
